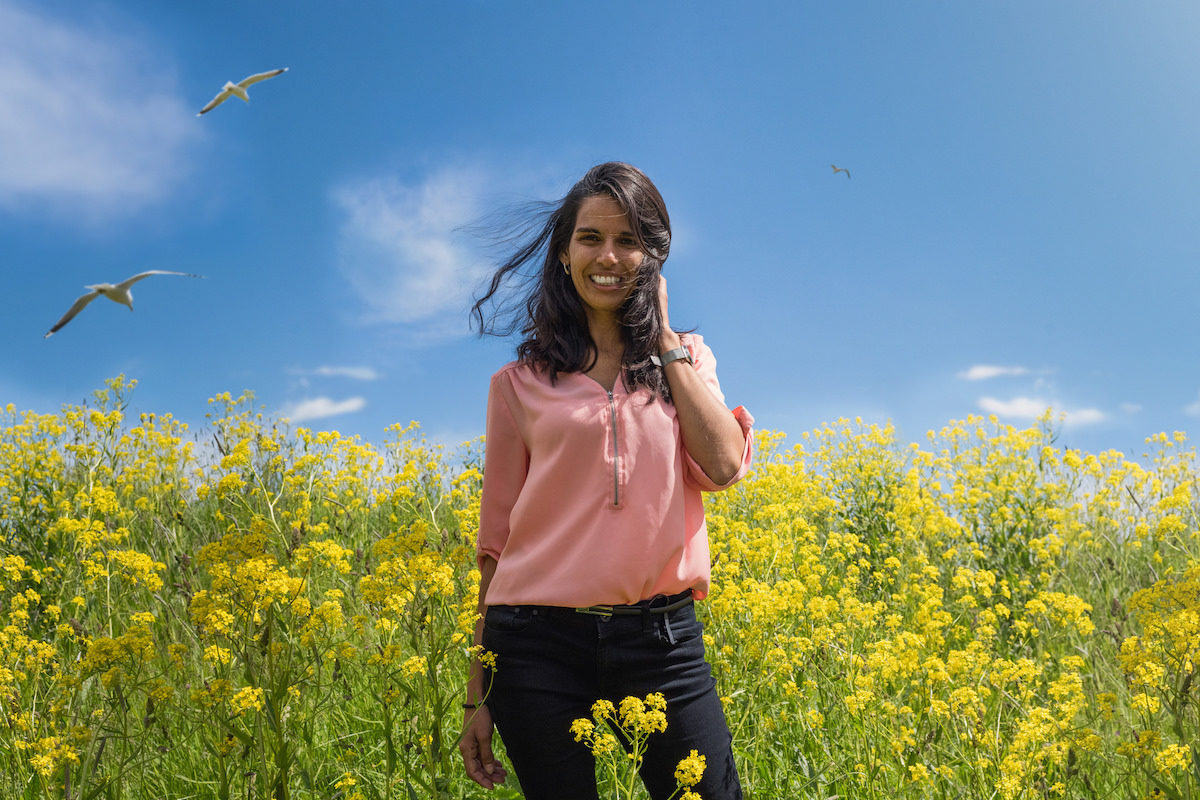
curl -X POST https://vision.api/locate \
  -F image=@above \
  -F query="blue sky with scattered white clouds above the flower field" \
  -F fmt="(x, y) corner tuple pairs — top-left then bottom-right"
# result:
(0, 0), (1200, 456)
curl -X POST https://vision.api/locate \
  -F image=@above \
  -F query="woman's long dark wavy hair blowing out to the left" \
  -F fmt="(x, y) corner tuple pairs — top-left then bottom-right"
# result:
(470, 161), (671, 402)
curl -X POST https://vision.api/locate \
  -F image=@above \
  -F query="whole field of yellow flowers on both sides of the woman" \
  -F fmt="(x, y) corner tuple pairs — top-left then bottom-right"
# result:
(0, 379), (1200, 800)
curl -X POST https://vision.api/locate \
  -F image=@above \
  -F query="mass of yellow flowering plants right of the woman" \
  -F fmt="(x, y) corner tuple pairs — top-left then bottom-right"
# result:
(704, 417), (1200, 800)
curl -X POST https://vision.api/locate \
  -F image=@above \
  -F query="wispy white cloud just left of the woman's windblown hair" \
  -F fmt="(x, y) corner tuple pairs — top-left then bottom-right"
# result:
(334, 169), (490, 335)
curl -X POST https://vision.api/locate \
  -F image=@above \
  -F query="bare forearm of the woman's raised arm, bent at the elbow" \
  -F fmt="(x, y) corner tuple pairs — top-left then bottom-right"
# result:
(659, 329), (745, 485)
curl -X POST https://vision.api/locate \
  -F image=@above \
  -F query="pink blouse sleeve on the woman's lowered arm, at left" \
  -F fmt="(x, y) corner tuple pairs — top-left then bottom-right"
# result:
(475, 371), (529, 565)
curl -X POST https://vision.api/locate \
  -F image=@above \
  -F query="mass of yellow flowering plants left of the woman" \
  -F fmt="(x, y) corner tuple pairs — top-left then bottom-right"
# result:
(0, 378), (494, 800)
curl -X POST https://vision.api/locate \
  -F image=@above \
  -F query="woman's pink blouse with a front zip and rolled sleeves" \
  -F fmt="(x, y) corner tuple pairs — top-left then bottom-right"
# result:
(478, 335), (754, 606)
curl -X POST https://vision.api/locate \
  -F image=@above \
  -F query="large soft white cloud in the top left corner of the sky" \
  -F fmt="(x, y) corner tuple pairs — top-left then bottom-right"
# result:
(0, 0), (199, 221)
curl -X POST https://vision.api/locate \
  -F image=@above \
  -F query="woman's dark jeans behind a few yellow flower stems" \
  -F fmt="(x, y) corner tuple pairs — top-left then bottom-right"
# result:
(484, 604), (742, 800)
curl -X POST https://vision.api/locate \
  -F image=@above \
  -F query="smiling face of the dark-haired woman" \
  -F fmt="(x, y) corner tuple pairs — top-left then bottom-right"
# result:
(559, 194), (644, 319)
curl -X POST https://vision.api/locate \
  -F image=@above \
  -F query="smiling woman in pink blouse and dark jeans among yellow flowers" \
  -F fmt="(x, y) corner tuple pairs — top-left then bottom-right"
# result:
(460, 163), (754, 800)
